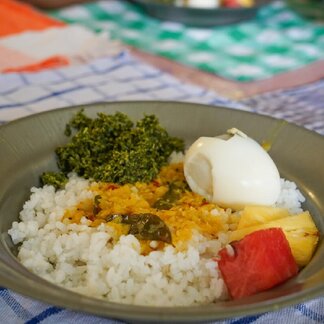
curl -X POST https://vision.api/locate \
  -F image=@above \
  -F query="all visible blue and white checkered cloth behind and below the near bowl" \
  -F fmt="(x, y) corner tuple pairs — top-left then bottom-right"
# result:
(0, 52), (324, 324)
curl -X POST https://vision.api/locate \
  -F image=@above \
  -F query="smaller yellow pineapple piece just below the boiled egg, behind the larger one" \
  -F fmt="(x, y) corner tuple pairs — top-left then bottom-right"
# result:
(237, 206), (289, 229)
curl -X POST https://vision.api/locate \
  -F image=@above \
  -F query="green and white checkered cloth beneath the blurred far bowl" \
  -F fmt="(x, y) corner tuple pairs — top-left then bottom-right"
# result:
(50, 0), (324, 82)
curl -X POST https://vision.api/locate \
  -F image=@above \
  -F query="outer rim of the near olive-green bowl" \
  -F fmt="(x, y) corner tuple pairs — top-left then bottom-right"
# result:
(0, 101), (324, 322)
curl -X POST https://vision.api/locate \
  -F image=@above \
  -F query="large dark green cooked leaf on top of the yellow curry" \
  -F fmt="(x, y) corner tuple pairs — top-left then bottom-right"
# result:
(106, 213), (172, 243)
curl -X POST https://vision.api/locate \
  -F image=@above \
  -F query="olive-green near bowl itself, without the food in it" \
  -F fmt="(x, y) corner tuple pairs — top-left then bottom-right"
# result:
(0, 102), (324, 323)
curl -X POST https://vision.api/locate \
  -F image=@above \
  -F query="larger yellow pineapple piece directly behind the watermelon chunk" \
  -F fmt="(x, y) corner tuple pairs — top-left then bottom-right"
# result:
(230, 211), (319, 267)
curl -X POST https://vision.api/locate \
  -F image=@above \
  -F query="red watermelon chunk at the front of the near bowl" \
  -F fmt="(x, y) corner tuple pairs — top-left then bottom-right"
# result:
(218, 228), (298, 299)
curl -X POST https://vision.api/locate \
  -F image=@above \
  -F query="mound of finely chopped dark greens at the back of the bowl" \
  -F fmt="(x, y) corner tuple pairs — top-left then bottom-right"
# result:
(42, 111), (184, 187)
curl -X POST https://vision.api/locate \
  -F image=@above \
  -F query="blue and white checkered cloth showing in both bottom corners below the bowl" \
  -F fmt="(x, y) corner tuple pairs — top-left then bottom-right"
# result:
(0, 288), (324, 324)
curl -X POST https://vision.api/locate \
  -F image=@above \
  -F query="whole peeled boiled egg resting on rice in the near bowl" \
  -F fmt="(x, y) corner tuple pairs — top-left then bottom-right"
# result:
(184, 129), (280, 209)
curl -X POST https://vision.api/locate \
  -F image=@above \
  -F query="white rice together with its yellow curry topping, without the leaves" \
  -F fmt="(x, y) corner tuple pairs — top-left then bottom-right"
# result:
(9, 163), (303, 306)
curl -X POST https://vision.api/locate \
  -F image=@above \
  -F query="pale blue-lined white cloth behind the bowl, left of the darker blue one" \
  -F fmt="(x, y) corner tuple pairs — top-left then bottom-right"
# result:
(0, 51), (244, 123)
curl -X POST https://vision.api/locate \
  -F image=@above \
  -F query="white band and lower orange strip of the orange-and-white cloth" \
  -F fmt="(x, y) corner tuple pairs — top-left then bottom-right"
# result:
(0, 23), (121, 72)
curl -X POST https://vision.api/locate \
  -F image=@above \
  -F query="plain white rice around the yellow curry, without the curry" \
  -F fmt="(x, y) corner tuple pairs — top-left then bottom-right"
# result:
(9, 176), (304, 306)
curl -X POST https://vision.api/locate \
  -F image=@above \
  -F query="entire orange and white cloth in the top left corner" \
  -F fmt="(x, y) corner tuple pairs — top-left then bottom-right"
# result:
(0, 0), (120, 73)
